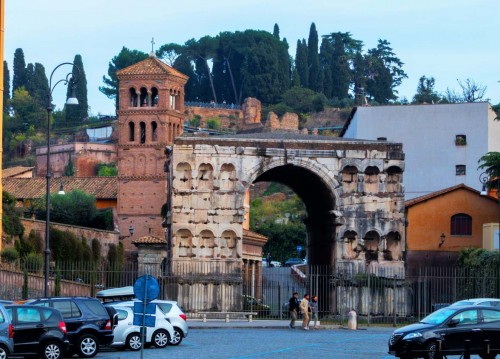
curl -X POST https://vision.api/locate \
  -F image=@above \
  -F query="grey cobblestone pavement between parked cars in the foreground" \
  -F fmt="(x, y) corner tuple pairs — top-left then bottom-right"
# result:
(98, 328), (400, 359)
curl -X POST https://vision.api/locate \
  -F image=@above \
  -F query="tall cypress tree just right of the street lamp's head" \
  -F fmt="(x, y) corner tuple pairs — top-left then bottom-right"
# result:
(65, 55), (89, 124)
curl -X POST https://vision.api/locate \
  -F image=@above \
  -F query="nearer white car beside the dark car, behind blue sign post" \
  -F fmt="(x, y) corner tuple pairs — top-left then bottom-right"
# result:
(107, 303), (175, 351)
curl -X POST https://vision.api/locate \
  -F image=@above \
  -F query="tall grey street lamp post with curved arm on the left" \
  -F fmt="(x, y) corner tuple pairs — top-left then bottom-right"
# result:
(44, 62), (80, 297)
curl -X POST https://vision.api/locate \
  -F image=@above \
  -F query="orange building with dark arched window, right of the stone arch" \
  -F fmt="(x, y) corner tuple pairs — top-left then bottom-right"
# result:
(405, 184), (499, 273)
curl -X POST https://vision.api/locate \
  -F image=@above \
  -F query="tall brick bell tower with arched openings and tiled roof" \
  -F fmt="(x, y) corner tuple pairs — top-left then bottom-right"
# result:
(117, 53), (188, 252)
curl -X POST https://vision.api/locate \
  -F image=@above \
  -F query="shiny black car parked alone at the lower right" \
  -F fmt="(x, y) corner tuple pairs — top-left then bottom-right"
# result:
(389, 305), (500, 359)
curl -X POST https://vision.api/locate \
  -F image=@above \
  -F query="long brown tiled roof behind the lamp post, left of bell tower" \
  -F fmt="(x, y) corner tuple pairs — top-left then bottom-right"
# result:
(2, 177), (118, 199)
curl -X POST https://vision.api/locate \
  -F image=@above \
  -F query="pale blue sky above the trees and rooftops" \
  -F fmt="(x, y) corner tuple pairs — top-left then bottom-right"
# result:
(4, 0), (500, 115)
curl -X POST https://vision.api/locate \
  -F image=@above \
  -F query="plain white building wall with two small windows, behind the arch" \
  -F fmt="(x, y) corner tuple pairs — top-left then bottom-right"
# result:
(343, 102), (500, 200)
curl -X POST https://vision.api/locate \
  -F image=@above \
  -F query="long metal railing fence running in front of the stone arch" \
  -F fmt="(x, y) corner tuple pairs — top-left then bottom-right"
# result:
(0, 261), (500, 325)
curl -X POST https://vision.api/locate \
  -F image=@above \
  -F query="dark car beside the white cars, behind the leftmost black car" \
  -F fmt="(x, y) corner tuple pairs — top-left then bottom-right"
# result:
(26, 297), (117, 358)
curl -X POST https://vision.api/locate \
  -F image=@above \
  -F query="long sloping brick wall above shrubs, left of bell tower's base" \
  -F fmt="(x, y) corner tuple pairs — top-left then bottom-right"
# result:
(21, 218), (119, 256)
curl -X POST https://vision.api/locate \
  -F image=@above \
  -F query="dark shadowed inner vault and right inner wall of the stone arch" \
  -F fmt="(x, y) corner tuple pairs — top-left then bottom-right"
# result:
(249, 163), (338, 265)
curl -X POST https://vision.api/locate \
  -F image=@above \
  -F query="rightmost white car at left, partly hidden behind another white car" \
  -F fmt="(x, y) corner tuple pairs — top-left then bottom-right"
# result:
(108, 299), (189, 345)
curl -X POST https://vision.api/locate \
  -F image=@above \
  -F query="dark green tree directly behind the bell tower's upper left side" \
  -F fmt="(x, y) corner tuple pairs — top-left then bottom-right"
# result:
(99, 46), (148, 109)
